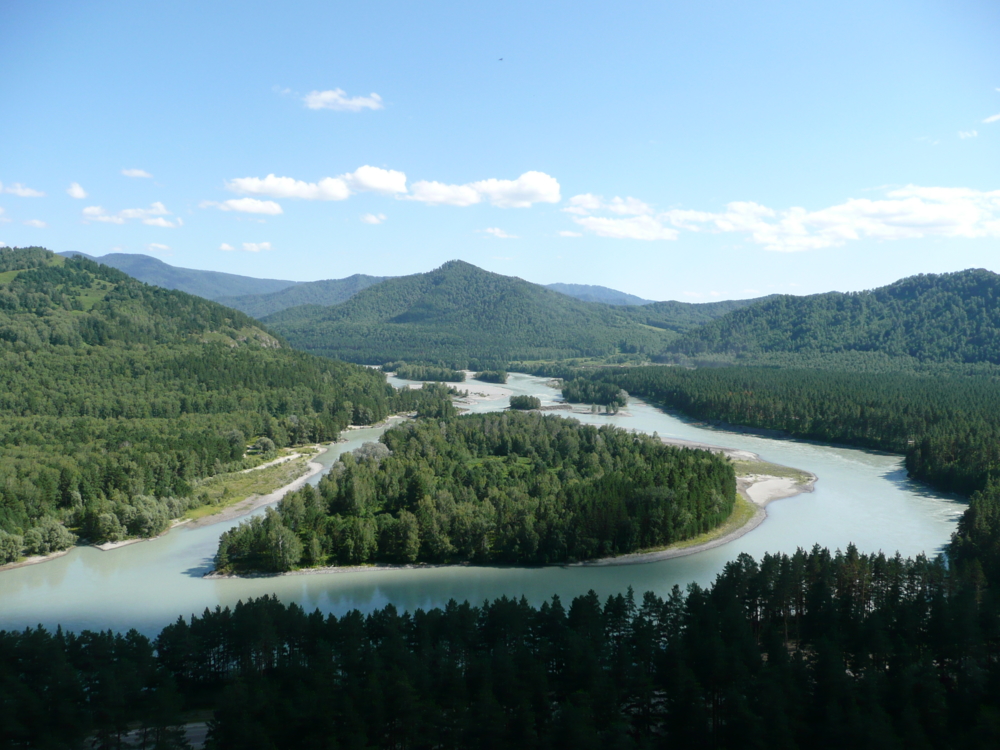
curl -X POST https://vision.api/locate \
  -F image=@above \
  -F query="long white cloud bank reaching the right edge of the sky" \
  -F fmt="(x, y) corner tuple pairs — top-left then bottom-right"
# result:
(657, 185), (1000, 252)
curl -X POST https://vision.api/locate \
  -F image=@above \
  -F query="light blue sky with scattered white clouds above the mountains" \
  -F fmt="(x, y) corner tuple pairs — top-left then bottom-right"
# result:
(0, 0), (1000, 301)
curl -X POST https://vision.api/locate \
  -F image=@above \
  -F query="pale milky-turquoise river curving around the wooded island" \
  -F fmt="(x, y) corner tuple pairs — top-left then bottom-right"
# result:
(0, 375), (964, 635)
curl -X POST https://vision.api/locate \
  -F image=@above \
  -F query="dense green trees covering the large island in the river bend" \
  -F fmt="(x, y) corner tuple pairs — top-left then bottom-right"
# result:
(216, 412), (736, 571)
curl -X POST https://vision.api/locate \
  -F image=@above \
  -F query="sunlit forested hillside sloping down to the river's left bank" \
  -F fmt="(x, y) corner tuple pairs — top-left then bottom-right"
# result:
(0, 248), (450, 562)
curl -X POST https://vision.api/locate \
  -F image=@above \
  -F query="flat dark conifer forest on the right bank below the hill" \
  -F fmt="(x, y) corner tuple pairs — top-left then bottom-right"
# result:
(590, 367), (1000, 495)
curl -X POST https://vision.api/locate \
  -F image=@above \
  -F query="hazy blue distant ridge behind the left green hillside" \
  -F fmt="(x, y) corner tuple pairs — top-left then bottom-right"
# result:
(60, 252), (298, 300)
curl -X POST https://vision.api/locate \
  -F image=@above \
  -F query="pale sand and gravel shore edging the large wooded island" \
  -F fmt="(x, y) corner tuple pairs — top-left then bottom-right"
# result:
(204, 438), (819, 580)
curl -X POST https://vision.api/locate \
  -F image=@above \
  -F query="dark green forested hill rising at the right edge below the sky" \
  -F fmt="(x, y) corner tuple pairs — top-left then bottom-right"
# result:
(669, 269), (1000, 364)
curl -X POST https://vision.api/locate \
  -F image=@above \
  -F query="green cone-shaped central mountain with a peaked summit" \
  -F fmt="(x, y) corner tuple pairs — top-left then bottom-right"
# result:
(265, 261), (669, 369)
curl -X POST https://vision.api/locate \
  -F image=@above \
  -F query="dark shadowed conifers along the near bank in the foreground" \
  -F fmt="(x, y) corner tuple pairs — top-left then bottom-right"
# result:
(0, 486), (1000, 750)
